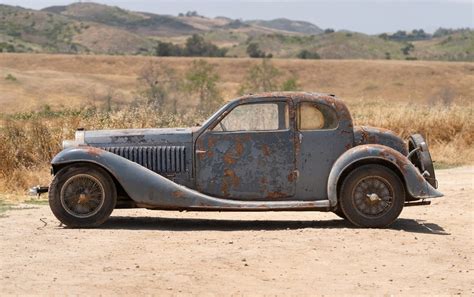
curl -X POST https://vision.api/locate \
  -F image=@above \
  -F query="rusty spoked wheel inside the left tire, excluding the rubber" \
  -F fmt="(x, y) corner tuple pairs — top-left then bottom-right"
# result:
(60, 174), (105, 218)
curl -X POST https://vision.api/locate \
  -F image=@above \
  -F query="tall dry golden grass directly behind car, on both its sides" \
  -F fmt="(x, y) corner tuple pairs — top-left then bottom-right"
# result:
(0, 100), (474, 192)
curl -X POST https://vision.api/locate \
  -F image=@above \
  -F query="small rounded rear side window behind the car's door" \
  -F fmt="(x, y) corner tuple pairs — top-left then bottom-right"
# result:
(298, 102), (338, 130)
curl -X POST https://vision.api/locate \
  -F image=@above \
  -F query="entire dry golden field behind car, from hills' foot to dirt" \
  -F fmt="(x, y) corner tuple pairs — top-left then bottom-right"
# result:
(0, 54), (474, 192)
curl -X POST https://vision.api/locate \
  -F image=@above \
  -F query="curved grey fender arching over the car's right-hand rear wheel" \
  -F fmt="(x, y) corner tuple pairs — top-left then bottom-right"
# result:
(328, 144), (443, 206)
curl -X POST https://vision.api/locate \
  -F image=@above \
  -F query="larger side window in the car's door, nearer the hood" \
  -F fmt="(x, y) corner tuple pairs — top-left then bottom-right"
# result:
(213, 102), (289, 131)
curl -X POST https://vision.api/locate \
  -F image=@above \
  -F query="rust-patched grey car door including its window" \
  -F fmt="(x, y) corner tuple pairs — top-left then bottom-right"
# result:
(195, 98), (296, 200)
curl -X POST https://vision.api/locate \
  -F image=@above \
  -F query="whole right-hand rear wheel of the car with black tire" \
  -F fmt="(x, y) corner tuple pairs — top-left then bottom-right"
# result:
(339, 164), (405, 228)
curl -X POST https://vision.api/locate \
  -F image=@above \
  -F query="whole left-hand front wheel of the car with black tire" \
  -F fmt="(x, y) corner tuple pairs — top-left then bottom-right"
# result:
(49, 164), (117, 228)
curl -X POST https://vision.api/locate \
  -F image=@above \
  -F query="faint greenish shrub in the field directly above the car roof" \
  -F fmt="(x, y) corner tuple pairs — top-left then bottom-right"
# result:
(239, 59), (280, 94)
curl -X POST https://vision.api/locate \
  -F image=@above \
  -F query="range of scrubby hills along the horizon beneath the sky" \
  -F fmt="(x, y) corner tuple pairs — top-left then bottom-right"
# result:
(0, 2), (474, 61)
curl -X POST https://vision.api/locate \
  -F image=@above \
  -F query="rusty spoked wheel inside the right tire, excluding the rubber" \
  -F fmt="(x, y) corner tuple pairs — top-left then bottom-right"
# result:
(352, 176), (393, 217)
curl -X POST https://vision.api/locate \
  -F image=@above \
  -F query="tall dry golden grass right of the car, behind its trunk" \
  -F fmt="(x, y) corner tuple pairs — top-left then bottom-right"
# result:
(349, 101), (474, 167)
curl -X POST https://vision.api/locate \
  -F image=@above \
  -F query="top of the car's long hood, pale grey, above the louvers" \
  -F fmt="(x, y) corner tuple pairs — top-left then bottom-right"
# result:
(63, 128), (193, 148)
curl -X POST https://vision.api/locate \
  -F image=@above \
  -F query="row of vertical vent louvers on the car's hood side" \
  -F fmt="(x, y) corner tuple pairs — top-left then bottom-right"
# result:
(102, 146), (186, 173)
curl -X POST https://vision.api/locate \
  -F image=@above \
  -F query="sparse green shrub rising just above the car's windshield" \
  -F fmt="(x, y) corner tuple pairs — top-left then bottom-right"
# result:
(185, 60), (223, 112)
